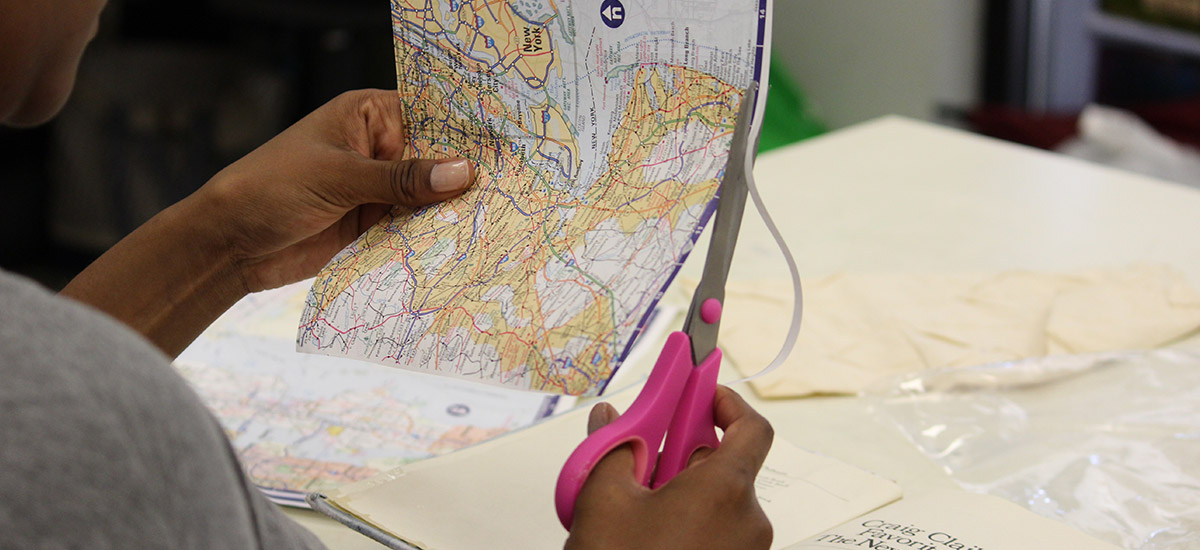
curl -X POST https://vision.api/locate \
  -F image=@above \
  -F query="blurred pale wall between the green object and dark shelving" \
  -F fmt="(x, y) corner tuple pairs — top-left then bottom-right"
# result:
(772, 0), (983, 128)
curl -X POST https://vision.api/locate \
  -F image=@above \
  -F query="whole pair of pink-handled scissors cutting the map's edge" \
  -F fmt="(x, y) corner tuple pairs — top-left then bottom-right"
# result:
(554, 82), (758, 530)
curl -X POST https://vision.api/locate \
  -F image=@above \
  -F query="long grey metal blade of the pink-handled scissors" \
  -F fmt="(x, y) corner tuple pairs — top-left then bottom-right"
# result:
(683, 80), (758, 365)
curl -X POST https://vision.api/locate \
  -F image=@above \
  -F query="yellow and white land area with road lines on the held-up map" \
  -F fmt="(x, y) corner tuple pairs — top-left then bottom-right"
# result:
(301, 0), (742, 395)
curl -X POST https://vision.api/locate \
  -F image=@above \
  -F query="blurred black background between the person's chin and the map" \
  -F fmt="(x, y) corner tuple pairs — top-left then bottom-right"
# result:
(0, 0), (396, 288)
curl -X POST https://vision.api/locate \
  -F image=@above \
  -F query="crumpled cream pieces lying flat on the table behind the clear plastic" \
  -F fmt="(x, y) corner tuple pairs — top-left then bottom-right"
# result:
(705, 264), (1200, 397)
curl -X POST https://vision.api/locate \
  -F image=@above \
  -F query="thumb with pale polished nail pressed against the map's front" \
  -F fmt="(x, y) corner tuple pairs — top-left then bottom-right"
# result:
(366, 159), (475, 207)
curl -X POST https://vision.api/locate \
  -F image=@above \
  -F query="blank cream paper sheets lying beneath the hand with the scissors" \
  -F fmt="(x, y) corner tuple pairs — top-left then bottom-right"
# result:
(309, 390), (900, 550)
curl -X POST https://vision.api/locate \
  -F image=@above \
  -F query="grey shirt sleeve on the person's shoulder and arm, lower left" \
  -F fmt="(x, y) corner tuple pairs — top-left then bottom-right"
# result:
(0, 271), (322, 549)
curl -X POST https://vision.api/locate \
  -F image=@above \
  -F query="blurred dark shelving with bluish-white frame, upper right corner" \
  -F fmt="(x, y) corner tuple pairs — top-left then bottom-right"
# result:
(965, 0), (1200, 149)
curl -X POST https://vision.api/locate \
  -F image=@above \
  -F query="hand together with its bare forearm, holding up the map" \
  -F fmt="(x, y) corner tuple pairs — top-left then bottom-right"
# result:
(62, 90), (475, 357)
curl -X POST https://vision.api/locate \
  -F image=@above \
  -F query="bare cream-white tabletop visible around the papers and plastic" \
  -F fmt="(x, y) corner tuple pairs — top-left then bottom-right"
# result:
(288, 116), (1200, 549)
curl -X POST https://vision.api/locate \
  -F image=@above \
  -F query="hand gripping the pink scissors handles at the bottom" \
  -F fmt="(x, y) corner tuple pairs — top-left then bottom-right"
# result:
(565, 387), (774, 550)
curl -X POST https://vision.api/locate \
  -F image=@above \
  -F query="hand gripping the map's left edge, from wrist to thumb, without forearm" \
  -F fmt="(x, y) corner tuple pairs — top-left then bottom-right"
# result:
(192, 90), (475, 292)
